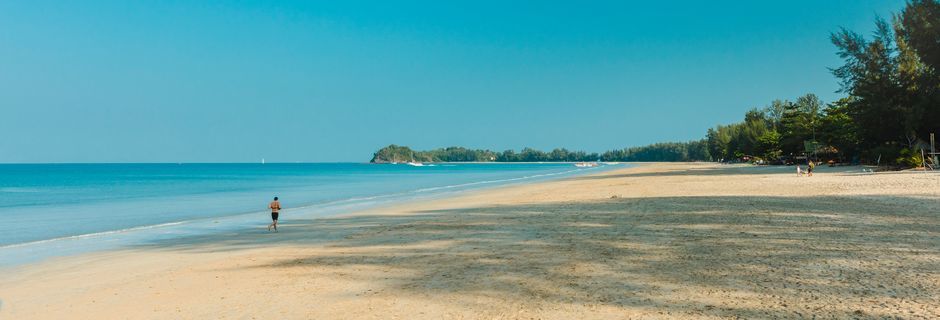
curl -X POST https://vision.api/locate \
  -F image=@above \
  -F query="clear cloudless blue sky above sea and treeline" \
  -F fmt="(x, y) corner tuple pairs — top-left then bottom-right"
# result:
(0, 0), (904, 163)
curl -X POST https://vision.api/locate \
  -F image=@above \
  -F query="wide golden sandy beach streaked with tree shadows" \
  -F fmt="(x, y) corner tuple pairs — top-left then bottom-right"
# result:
(0, 163), (940, 319)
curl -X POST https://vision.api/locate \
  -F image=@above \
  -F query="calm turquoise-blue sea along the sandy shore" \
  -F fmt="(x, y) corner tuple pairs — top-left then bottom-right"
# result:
(0, 163), (624, 267)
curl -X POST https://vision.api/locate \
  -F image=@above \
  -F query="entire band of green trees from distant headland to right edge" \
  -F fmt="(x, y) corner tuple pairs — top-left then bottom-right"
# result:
(372, 0), (940, 167)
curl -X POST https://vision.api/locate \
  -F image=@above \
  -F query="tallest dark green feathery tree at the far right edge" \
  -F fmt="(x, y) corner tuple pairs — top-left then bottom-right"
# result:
(832, 0), (940, 166)
